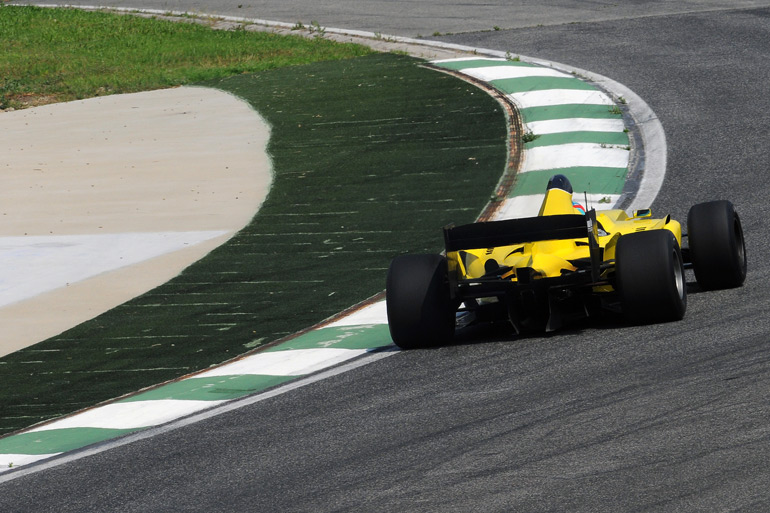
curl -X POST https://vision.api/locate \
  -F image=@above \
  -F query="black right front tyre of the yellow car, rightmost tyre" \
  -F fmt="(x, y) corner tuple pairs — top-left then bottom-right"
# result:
(687, 200), (746, 290)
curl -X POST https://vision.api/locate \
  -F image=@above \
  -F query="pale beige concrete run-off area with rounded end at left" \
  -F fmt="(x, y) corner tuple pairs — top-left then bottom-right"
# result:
(0, 87), (271, 356)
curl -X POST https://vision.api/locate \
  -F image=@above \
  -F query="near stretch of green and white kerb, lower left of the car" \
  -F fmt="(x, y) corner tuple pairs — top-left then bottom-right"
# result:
(0, 302), (392, 473)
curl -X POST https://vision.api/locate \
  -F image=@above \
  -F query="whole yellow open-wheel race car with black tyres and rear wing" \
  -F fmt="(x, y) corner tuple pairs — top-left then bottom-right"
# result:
(386, 175), (746, 349)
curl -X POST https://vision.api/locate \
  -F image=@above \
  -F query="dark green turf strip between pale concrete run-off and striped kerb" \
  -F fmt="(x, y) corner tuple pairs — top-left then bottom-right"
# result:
(0, 55), (506, 433)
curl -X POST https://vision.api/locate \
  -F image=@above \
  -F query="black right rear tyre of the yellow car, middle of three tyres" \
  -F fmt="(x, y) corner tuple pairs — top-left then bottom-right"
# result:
(615, 230), (687, 324)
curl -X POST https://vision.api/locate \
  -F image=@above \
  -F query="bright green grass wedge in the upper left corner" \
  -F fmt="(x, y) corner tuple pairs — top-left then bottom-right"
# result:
(0, 3), (372, 109)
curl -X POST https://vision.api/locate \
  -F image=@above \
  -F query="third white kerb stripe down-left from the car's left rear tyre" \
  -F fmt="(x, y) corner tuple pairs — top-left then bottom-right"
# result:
(28, 399), (226, 433)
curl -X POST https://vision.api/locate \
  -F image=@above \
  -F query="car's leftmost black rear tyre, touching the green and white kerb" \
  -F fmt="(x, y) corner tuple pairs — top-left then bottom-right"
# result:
(385, 255), (456, 349)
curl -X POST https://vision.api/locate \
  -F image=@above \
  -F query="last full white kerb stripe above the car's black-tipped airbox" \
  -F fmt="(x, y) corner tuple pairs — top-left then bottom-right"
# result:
(520, 143), (630, 173)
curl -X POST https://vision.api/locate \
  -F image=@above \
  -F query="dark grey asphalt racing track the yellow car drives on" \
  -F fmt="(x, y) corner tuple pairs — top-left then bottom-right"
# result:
(0, 1), (770, 512)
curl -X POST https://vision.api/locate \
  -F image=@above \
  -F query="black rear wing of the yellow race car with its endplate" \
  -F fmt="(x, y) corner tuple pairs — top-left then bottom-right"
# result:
(444, 209), (601, 281)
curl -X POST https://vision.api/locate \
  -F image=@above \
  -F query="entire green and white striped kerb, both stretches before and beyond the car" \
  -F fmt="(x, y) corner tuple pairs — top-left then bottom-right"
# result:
(0, 54), (630, 473)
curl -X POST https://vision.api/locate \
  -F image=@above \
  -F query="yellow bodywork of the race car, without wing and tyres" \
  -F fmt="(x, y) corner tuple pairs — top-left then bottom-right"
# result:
(447, 189), (682, 292)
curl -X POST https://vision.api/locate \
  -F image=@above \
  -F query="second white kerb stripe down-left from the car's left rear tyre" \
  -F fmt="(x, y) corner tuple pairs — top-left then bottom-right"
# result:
(194, 347), (366, 378)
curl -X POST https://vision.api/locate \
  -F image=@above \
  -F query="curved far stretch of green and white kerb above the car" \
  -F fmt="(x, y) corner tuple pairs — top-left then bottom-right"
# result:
(433, 57), (630, 219)
